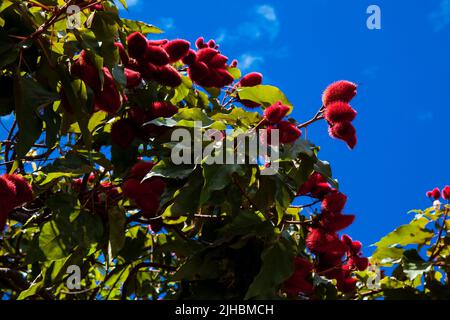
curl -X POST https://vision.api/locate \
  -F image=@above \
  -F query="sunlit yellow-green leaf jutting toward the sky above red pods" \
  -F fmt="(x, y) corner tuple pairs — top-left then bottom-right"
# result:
(239, 85), (293, 111)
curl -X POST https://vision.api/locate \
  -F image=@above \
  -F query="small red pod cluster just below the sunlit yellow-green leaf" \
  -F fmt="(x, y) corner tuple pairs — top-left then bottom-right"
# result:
(261, 101), (302, 144)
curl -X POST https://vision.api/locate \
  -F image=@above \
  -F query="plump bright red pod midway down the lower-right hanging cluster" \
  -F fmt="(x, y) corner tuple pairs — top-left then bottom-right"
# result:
(306, 228), (347, 253)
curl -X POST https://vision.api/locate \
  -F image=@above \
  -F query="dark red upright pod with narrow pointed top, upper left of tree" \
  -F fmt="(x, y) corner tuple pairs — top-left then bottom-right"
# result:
(94, 67), (122, 114)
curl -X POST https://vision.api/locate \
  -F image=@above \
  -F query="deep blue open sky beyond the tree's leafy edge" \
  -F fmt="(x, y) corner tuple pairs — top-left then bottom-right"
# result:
(117, 0), (450, 253)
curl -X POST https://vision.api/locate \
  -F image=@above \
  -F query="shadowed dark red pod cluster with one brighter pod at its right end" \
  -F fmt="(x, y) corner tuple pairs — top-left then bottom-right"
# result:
(111, 102), (178, 149)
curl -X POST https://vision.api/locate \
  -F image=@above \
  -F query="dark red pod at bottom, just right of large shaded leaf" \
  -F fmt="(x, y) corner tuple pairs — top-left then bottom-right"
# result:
(283, 257), (314, 296)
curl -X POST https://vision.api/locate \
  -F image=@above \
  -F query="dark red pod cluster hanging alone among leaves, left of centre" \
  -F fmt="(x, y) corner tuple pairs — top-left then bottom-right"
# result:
(122, 161), (166, 218)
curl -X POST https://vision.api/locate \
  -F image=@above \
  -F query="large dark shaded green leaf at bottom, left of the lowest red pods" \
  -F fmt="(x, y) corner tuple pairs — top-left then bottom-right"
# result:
(245, 238), (295, 300)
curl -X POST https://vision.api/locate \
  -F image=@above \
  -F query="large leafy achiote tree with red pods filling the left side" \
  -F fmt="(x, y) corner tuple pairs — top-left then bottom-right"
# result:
(0, 0), (369, 299)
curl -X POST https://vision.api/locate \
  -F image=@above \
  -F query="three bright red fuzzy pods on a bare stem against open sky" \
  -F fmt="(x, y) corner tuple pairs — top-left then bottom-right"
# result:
(322, 80), (357, 149)
